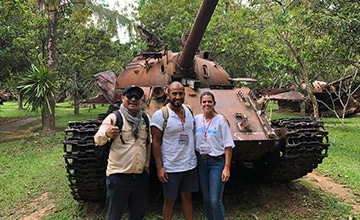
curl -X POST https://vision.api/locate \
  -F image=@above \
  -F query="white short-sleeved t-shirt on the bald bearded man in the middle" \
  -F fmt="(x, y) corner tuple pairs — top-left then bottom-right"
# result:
(150, 104), (197, 173)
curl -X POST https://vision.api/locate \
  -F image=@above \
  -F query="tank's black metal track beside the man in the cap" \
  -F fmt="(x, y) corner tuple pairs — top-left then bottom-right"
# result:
(64, 120), (106, 202)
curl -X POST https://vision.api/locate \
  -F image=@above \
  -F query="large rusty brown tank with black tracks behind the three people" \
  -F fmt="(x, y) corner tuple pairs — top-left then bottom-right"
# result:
(64, 0), (329, 201)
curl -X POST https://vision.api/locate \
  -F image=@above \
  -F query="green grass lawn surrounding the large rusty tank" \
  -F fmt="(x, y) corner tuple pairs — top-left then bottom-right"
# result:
(0, 102), (360, 219)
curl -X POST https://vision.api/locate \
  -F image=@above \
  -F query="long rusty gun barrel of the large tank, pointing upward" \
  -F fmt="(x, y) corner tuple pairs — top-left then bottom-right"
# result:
(178, 0), (218, 68)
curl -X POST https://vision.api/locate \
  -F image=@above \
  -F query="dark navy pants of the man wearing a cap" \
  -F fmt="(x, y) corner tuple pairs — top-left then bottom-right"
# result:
(106, 171), (149, 220)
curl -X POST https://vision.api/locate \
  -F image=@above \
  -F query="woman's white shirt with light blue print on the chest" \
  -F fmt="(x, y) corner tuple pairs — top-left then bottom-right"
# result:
(195, 114), (235, 156)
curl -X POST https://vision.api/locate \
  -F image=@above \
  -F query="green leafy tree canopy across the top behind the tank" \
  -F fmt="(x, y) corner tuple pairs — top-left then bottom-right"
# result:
(0, 0), (360, 120)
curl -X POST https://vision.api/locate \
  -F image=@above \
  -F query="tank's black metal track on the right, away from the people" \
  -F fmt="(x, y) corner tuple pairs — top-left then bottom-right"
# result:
(254, 118), (329, 181)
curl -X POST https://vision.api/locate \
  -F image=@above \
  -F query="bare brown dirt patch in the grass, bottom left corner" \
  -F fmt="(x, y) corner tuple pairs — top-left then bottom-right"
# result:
(8, 192), (55, 220)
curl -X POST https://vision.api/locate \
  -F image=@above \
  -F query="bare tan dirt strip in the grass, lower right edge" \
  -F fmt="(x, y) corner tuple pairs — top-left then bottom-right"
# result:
(302, 171), (360, 214)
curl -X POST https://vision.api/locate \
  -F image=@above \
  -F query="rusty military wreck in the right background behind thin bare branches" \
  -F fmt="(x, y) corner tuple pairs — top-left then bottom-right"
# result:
(255, 74), (360, 117)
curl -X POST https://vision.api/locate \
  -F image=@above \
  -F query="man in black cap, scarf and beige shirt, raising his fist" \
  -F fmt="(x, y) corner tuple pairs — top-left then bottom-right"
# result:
(94, 86), (150, 220)
